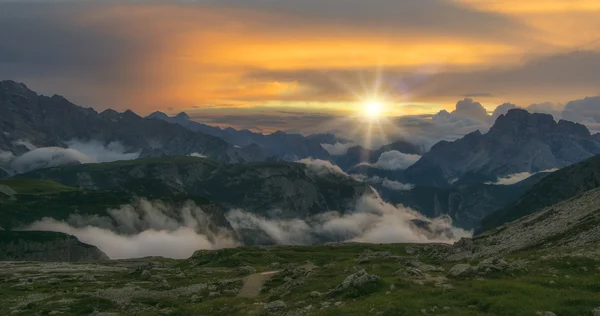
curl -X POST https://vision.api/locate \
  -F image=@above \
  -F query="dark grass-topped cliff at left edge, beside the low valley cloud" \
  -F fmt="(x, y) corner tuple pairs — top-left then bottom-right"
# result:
(0, 231), (108, 262)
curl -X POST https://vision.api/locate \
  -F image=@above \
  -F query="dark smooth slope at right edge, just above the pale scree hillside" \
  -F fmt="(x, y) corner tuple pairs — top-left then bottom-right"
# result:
(479, 156), (600, 232)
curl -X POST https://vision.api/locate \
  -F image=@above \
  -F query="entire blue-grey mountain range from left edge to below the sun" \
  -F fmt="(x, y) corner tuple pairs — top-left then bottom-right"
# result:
(0, 80), (338, 177)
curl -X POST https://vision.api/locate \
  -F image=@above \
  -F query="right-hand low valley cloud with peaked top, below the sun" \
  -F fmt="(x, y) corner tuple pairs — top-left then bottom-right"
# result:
(226, 196), (471, 245)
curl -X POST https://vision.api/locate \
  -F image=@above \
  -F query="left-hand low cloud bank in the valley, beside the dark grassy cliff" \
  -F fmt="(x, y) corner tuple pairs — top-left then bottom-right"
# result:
(26, 199), (238, 259)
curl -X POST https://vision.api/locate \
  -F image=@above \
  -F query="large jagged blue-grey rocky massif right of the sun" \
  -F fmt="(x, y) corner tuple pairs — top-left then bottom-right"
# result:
(406, 109), (600, 186)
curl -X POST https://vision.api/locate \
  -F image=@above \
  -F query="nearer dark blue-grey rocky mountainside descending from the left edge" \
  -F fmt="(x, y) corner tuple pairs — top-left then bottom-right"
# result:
(0, 81), (270, 167)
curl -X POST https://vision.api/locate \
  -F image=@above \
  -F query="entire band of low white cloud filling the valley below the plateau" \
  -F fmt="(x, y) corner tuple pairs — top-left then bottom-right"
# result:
(25, 194), (471, 259)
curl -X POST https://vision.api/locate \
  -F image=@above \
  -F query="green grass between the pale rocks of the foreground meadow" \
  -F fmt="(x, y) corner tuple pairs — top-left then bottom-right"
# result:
(0, 244), (600, 316)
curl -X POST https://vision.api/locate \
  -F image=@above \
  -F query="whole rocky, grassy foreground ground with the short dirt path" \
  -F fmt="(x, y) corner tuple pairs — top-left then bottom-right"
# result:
(0, 243), (600, 316)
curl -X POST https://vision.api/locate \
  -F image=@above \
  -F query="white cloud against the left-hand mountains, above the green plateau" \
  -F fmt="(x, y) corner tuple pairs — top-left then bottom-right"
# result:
(6, 140), (140, 173)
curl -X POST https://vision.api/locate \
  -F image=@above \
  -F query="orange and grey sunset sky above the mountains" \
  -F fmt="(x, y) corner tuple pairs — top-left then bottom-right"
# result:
(0, 0), (600, 131)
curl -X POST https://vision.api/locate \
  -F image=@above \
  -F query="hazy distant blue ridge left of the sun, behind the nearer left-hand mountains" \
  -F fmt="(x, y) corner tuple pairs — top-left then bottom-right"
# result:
(148, 112), (340, 161)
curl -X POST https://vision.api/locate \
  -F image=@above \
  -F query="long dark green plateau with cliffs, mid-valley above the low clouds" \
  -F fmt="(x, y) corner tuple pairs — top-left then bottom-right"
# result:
(22, 157), (371, 218)
